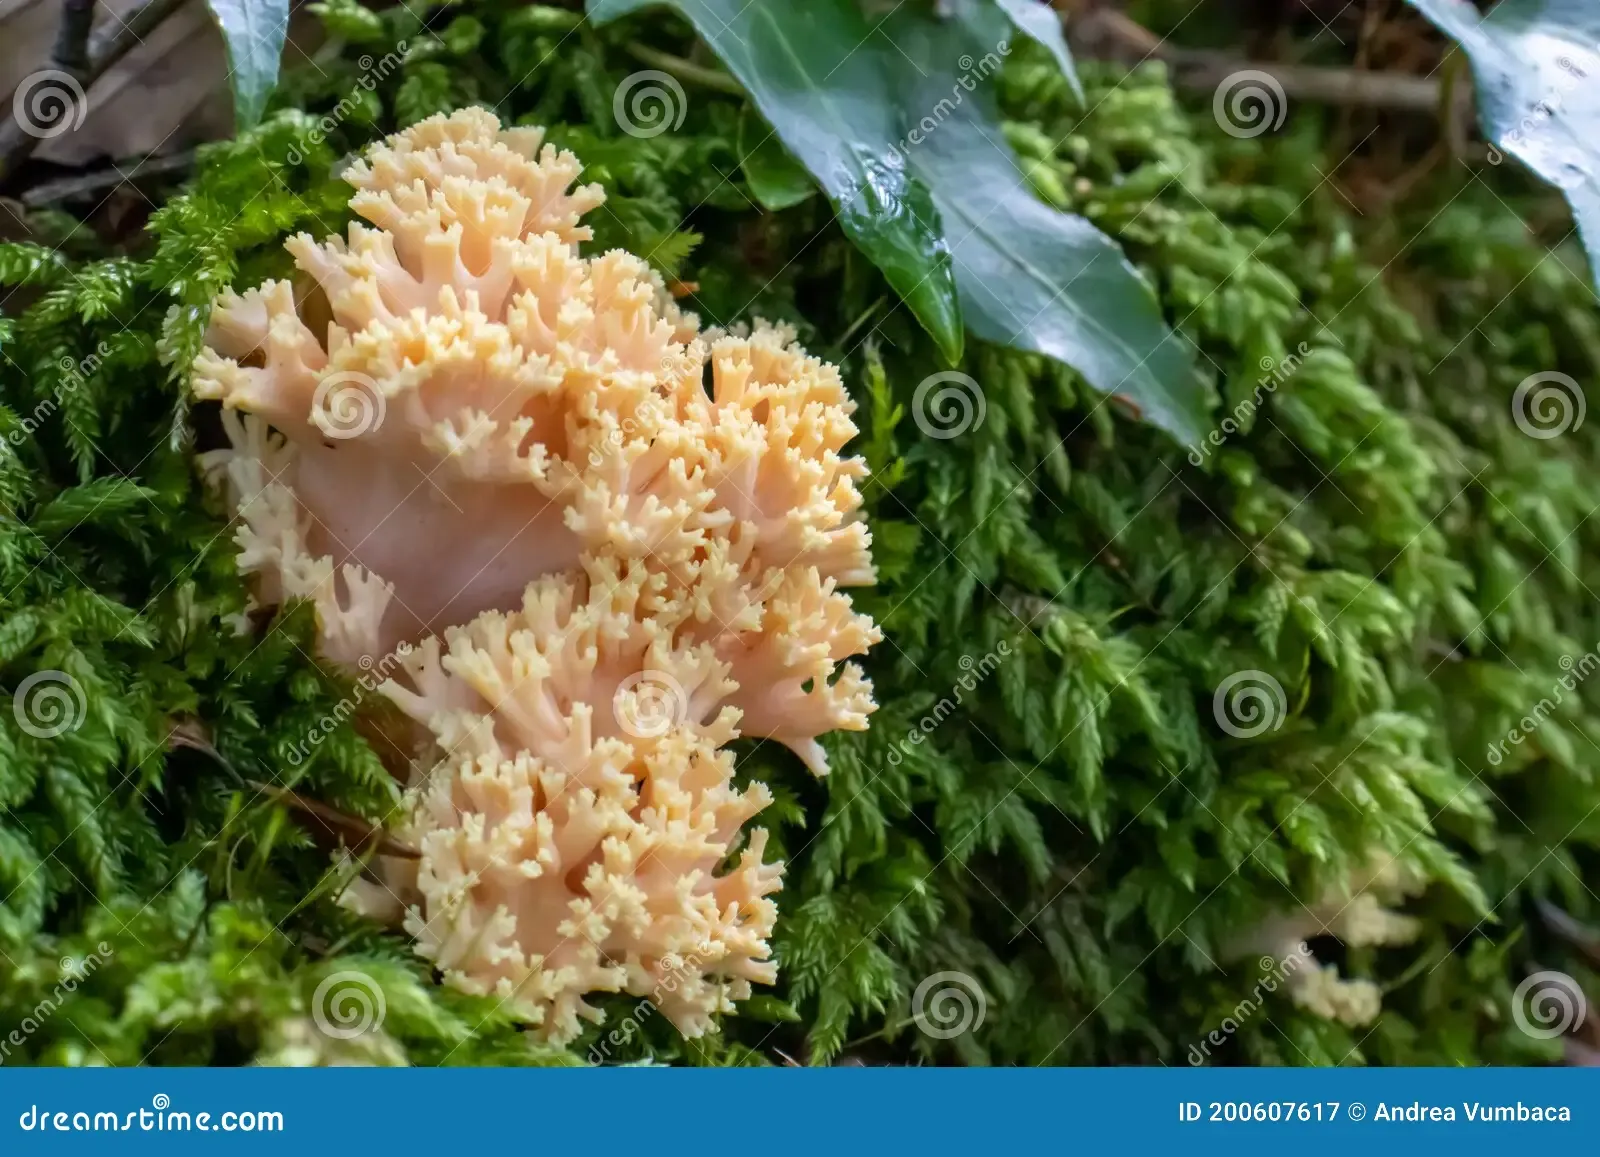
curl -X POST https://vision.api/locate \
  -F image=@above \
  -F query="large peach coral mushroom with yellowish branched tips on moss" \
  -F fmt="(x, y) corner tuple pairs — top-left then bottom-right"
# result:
(194, 109), (880, 1042)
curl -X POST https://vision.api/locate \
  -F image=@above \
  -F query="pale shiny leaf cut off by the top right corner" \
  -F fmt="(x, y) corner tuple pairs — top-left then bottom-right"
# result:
(1411, 0), (1600, 278)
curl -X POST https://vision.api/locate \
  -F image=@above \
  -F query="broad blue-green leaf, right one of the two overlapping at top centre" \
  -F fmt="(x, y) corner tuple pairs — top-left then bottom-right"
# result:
(877, 14), (1208, 445)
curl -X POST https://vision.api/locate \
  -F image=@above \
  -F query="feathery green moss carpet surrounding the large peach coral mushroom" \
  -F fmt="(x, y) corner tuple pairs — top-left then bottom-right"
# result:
(0, 3), (1600, 1064)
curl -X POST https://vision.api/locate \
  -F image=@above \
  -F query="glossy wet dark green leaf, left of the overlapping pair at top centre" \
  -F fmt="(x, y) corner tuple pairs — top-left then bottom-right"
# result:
(587, 0), (965, 363)
